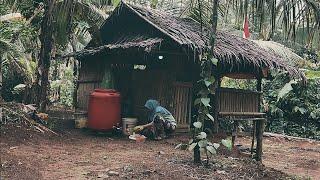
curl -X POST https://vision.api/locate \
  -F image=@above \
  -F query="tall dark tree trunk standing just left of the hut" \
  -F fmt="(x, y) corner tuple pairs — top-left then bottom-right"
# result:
(36, 0), (55, 112)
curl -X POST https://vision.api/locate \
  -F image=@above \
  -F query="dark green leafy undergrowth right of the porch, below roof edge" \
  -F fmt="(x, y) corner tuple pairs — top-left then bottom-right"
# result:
(264, 75), (320, 139)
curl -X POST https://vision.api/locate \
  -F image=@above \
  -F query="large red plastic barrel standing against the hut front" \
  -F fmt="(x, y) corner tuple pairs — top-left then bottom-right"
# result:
(88, 89), (121, 131)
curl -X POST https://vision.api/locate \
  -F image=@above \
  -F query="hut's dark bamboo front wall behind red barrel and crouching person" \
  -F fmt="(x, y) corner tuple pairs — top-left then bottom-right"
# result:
(77, 54), (192, 129)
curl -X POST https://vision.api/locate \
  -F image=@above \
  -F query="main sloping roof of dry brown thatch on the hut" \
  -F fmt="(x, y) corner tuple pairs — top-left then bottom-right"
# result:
(67, 2), (304, 81)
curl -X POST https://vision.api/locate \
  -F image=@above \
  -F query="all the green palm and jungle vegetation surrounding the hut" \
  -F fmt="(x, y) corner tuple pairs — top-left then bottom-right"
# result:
(0, 0), (320, 139)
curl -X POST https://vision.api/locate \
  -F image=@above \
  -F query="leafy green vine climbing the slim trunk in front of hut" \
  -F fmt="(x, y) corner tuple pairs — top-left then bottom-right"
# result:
(188, 54), (231, 164)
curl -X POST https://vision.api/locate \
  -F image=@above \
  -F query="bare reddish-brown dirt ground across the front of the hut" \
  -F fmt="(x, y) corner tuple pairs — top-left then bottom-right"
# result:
(0, 119), (320, 180)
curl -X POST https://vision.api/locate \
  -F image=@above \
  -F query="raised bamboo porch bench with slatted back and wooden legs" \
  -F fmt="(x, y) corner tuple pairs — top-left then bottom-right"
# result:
(217, 88), (266, 160)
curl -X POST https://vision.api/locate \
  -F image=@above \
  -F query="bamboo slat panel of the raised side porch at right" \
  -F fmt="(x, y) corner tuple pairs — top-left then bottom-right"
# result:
(218, 88), (261, 115)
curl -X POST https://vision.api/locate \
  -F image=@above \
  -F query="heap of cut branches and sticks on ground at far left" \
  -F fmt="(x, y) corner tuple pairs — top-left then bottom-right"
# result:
(0, 102), (58, 135)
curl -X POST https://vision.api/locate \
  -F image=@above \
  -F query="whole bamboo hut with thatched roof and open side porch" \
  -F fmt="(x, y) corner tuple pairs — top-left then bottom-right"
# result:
(73, 2), (303, 159)
